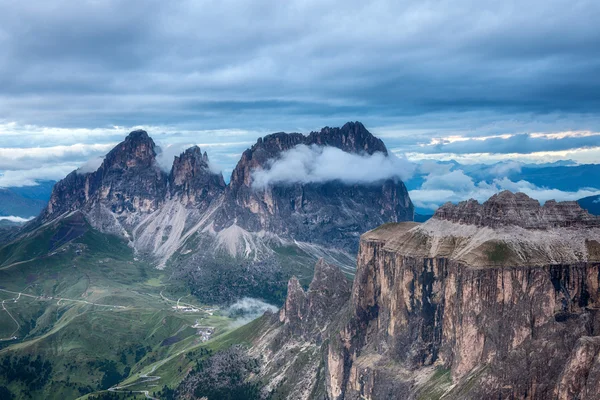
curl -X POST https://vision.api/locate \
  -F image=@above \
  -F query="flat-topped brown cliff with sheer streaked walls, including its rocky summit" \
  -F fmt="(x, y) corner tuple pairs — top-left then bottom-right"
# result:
(327, 193), (600, 399)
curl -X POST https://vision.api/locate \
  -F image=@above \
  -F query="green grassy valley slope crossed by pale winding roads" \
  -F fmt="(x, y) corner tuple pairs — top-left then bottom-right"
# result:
(0, 217), (239, 399)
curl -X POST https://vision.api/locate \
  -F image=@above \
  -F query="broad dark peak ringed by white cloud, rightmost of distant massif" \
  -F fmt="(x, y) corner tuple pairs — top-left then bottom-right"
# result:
(214, 122), (414, 252)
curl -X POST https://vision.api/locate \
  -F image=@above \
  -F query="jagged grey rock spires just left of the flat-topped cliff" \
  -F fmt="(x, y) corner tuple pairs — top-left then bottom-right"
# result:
(249, 260), (350, 400)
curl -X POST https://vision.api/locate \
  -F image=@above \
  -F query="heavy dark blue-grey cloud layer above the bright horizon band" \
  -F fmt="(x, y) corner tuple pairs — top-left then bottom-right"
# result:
(0, 0), (600, 127)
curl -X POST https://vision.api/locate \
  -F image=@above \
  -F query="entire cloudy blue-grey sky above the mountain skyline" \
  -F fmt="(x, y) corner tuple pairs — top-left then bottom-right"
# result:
(0, 0), (600, 209)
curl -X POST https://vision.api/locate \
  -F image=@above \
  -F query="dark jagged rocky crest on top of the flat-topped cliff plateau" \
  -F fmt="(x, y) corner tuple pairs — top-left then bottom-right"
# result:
(433, 190), (600, 229)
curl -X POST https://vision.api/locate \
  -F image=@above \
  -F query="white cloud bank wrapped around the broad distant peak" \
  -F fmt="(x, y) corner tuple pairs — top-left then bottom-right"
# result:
(252, 145), (414, 189)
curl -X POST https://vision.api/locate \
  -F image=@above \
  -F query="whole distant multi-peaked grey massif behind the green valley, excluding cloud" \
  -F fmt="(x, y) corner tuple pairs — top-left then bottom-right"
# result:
(27, 122), (414, 304)
